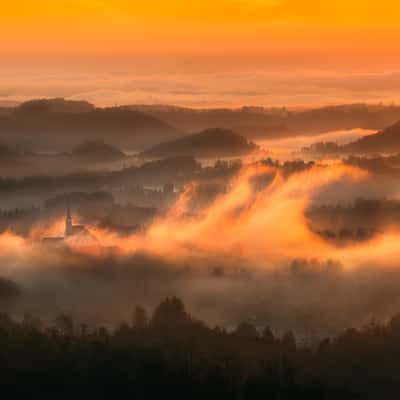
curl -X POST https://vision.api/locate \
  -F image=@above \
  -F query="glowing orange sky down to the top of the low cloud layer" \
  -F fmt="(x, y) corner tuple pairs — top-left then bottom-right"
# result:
(0, 0), (400, 106)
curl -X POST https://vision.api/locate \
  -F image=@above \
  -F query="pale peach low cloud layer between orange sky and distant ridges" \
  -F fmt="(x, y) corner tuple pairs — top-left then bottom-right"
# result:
(0, 69), (400, 107)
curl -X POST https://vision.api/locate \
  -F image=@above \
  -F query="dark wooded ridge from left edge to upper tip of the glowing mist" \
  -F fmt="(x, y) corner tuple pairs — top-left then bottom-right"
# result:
(0, 156), (314, 200)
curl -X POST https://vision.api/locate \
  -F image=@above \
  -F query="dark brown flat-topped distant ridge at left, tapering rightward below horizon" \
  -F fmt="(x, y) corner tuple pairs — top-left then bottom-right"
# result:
(0, 99), (183, 151)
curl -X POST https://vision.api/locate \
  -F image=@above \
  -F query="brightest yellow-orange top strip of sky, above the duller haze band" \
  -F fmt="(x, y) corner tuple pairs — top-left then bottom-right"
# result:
(0, 0), (400, 59)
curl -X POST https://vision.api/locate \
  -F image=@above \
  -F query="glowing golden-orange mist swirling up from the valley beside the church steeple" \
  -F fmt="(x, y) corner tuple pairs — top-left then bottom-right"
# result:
(0, 164), (399, 270)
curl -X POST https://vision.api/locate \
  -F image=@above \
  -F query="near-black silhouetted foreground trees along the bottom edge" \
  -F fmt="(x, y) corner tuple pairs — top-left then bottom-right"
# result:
(0, 298), (400, 399)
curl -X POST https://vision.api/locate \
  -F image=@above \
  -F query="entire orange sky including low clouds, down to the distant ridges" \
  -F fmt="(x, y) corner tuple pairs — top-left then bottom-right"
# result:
(0, 0), (400, 105)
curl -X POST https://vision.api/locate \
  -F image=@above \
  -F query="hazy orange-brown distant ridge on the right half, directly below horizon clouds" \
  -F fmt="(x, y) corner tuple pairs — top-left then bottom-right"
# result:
(130, 103), (400, 140)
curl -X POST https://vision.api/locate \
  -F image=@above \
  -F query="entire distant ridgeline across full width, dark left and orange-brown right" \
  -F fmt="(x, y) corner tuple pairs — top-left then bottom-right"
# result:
(0, 99), (400, 151)
